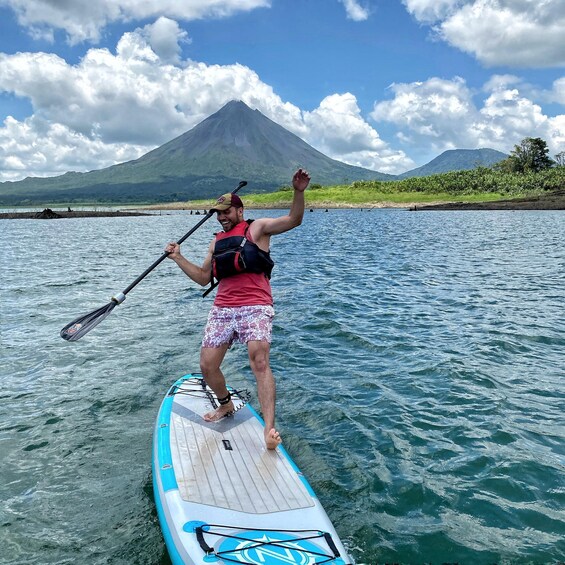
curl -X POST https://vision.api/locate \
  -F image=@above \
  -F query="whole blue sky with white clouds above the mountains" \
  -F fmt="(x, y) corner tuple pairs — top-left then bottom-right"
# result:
(0, 0), (565, 181)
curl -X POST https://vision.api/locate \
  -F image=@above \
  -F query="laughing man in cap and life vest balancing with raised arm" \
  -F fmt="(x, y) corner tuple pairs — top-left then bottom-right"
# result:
(165, 169), (310, 449)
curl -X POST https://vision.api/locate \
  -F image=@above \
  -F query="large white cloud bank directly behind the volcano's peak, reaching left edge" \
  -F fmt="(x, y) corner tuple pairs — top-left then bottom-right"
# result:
(0, 22), (412, 180)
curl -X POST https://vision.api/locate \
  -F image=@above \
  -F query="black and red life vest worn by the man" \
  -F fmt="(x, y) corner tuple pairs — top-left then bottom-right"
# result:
(205, 220), (275, 295)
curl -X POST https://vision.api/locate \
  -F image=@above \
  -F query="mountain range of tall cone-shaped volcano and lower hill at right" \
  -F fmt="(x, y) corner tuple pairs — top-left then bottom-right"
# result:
(0, 101), (506, 205)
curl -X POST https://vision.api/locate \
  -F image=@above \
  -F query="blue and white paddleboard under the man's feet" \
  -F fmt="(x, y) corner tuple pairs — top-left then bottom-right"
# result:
(153, 375), (352, 565)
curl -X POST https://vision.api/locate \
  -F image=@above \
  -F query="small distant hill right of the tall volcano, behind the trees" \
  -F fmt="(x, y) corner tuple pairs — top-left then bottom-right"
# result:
(397, 149), (508, 179)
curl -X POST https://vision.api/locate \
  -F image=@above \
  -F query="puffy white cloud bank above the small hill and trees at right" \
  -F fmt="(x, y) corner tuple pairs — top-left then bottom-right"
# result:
(371, 75), (565, 158)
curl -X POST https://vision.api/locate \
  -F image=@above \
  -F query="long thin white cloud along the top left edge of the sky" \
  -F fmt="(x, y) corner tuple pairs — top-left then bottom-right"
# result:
(0, 0), (271, 44)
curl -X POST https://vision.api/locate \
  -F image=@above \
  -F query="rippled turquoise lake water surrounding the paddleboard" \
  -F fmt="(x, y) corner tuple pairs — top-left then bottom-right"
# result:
(0, 210), (565, 565)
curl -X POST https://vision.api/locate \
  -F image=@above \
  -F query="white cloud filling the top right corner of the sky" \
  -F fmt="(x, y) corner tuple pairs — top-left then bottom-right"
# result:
(403, 0), (565, 67)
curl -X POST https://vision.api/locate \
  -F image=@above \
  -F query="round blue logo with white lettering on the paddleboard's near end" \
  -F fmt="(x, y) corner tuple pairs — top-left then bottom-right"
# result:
(217, 532), (323, 565)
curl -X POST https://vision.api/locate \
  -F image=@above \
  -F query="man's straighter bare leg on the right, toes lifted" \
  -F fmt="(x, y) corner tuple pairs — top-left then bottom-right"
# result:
(247, 341), (282, 449)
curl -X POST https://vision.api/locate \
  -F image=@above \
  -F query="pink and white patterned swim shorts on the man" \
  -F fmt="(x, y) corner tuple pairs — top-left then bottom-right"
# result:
(202, 306), (275, 347)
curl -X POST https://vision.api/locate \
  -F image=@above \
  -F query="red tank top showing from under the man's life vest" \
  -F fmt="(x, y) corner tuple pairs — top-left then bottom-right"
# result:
(214, 224), (273, 308)
